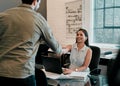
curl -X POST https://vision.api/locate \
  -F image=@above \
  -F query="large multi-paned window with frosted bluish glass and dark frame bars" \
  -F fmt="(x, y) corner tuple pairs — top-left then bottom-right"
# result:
(93, 0), (120, 44)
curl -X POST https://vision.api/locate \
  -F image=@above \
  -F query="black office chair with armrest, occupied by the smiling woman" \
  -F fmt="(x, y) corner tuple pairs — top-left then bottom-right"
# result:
(89, 46), (101, 86)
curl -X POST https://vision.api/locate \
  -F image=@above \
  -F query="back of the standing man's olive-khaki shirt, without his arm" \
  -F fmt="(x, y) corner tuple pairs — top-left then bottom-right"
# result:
(0, 5), (51, 77)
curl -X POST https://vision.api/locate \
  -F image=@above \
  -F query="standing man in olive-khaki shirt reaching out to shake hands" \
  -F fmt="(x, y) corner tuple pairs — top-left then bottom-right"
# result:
(0, 0), (62, 86)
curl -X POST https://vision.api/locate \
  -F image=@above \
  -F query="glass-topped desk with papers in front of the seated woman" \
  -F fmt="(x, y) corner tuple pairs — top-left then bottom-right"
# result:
(45, 72), (88, 86)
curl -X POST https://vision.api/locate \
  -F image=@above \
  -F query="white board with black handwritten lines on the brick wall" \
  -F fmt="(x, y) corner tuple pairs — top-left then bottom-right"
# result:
(65, 0), (82, 38)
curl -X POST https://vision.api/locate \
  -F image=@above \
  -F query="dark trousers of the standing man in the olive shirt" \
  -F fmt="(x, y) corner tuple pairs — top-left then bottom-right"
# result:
(0, 75), (36, 86)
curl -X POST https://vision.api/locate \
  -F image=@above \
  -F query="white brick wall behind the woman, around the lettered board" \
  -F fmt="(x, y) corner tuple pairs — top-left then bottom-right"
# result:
(47, 0), (91, 45)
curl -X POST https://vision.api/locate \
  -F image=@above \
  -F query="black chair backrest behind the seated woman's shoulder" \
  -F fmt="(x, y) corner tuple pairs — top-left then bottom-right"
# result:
(89, 46), (101, 71)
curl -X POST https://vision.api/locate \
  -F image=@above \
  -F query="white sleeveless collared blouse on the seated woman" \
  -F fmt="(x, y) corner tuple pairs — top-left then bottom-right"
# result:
(70, 43), (89, 72)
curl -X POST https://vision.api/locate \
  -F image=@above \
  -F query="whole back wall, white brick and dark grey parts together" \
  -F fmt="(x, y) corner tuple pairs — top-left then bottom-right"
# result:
(0, 0), (92, 45)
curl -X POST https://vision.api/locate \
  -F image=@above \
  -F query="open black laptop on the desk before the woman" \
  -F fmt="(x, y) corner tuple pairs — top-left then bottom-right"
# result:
(42, 55), (62, 74)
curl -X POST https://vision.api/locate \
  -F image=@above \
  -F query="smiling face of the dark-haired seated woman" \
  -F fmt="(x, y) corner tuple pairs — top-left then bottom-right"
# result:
(76, 31), (87, 43)
